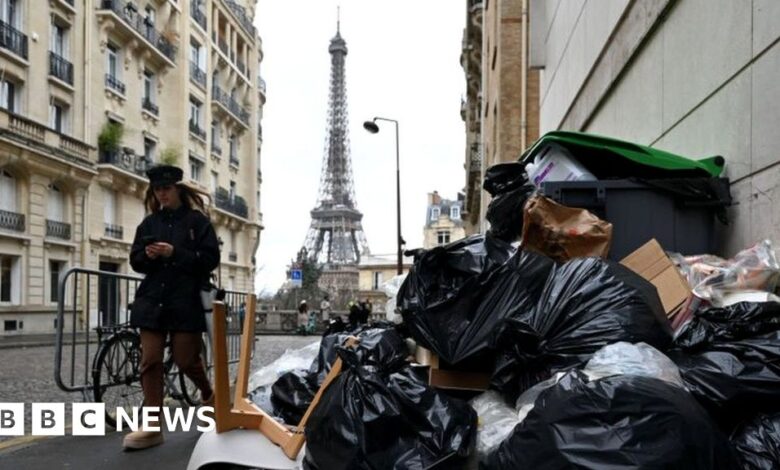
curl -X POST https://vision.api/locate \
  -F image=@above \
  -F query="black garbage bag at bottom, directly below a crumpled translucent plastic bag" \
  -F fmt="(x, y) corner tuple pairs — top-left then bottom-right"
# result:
(481, 371), (739, 470)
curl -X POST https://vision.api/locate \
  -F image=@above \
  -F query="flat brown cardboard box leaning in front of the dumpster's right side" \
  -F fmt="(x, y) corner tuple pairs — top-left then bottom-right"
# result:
(620, 239), (691, 318)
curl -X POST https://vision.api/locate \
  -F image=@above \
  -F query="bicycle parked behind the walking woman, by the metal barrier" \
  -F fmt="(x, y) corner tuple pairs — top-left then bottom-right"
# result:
(92, 323), (212, 428)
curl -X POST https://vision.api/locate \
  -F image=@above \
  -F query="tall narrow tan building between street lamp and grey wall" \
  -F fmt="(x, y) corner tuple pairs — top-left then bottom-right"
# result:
(461, 0), (539, 234)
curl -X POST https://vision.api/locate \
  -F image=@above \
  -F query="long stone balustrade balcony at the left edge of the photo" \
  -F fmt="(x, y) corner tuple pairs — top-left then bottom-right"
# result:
(0, 108), (92, 164)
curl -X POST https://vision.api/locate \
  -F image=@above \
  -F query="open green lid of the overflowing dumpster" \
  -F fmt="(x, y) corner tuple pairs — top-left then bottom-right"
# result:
(520, 131), (725, 177)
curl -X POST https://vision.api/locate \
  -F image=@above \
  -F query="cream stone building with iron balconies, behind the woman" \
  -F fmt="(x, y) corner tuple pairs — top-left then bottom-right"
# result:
(0, 0), (265, 334)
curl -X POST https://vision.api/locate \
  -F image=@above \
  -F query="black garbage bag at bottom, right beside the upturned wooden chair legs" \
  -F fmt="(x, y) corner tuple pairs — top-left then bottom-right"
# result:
(304, 334), (477, 470)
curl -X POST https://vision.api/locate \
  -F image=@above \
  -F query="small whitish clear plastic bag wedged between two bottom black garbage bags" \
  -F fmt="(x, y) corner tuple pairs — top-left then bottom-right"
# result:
(469, 390), (520, 459)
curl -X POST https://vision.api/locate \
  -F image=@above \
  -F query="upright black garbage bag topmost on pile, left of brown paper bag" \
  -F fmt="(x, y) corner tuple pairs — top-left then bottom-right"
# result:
(483, 162), (536, 242)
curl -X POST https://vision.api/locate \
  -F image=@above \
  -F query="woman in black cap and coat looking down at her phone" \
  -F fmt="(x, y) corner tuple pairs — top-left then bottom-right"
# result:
(123, 165), (219, 449)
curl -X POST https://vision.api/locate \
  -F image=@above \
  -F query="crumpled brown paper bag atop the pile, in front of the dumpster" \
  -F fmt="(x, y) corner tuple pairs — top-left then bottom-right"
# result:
(522, 195), (612, 262)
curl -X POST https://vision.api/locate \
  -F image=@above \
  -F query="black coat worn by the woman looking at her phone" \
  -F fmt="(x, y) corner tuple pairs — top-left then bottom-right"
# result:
(130, 205), (219, 331)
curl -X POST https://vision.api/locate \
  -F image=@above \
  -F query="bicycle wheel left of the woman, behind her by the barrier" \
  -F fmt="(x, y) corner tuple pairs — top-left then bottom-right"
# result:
(92, 331), (144, 428)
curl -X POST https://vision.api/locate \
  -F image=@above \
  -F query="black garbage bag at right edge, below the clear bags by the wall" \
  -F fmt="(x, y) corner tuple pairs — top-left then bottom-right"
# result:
(668, 302), (780, 428)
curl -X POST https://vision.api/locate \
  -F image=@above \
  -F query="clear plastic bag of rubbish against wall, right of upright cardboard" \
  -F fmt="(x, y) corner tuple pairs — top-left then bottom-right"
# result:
(671, 240), (780, 307)
